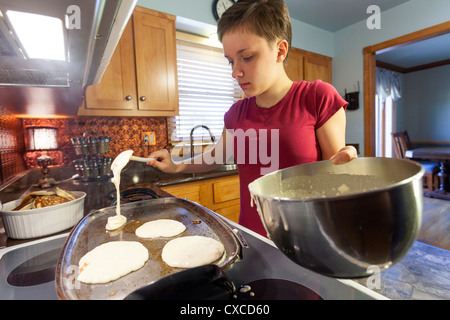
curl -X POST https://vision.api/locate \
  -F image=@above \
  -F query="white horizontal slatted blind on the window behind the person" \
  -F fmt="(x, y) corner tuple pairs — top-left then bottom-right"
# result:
(168, 39), (242, 144)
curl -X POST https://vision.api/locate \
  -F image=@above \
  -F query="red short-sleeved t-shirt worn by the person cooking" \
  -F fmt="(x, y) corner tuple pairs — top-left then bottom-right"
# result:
(224, 80), (347, 236)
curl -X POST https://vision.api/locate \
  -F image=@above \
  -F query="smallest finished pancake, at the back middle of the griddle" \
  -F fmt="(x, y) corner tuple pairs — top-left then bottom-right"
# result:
(136, 219), (186, 238)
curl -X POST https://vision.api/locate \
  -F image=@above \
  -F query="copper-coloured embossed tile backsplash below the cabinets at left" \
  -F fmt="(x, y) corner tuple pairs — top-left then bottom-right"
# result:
(0, 114), (168, 184)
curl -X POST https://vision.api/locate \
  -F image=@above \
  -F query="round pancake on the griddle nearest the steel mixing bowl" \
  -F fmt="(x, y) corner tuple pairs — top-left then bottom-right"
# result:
(161, 236), (225, 268)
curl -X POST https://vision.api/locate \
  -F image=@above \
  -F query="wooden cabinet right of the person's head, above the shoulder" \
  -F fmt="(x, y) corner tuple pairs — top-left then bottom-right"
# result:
(284, 48), (332, 83)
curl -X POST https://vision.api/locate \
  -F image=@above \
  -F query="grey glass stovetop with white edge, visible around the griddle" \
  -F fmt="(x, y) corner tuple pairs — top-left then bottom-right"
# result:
(0, 222), (384, 300)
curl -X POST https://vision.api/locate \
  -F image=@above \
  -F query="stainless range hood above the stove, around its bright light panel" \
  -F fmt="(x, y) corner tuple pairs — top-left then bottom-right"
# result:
(0, 0), (137, 89)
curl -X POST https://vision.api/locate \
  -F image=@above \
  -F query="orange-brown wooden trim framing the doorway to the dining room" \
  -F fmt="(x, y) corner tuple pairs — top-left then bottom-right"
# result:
(363, 21), (450, 157)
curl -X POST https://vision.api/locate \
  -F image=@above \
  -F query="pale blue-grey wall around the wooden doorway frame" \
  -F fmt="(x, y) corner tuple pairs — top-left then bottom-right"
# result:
(333, 0), (450, 154)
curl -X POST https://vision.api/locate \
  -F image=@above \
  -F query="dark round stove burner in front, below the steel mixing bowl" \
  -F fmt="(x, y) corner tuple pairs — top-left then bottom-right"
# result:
(235, 279), (323, 300)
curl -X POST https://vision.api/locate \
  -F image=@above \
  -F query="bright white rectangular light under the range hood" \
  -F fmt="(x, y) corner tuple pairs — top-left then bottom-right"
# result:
(6, 10), (66, 61)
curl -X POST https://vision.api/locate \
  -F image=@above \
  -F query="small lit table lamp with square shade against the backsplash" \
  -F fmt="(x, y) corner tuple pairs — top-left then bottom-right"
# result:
(27, 127), (58, 188)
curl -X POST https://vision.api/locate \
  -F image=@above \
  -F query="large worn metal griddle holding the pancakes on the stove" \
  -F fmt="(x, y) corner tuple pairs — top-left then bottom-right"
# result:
(56, 197), (241, 300)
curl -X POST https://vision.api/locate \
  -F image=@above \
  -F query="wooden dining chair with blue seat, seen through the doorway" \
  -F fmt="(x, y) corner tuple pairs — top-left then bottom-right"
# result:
(392, 131), (439, 192)
